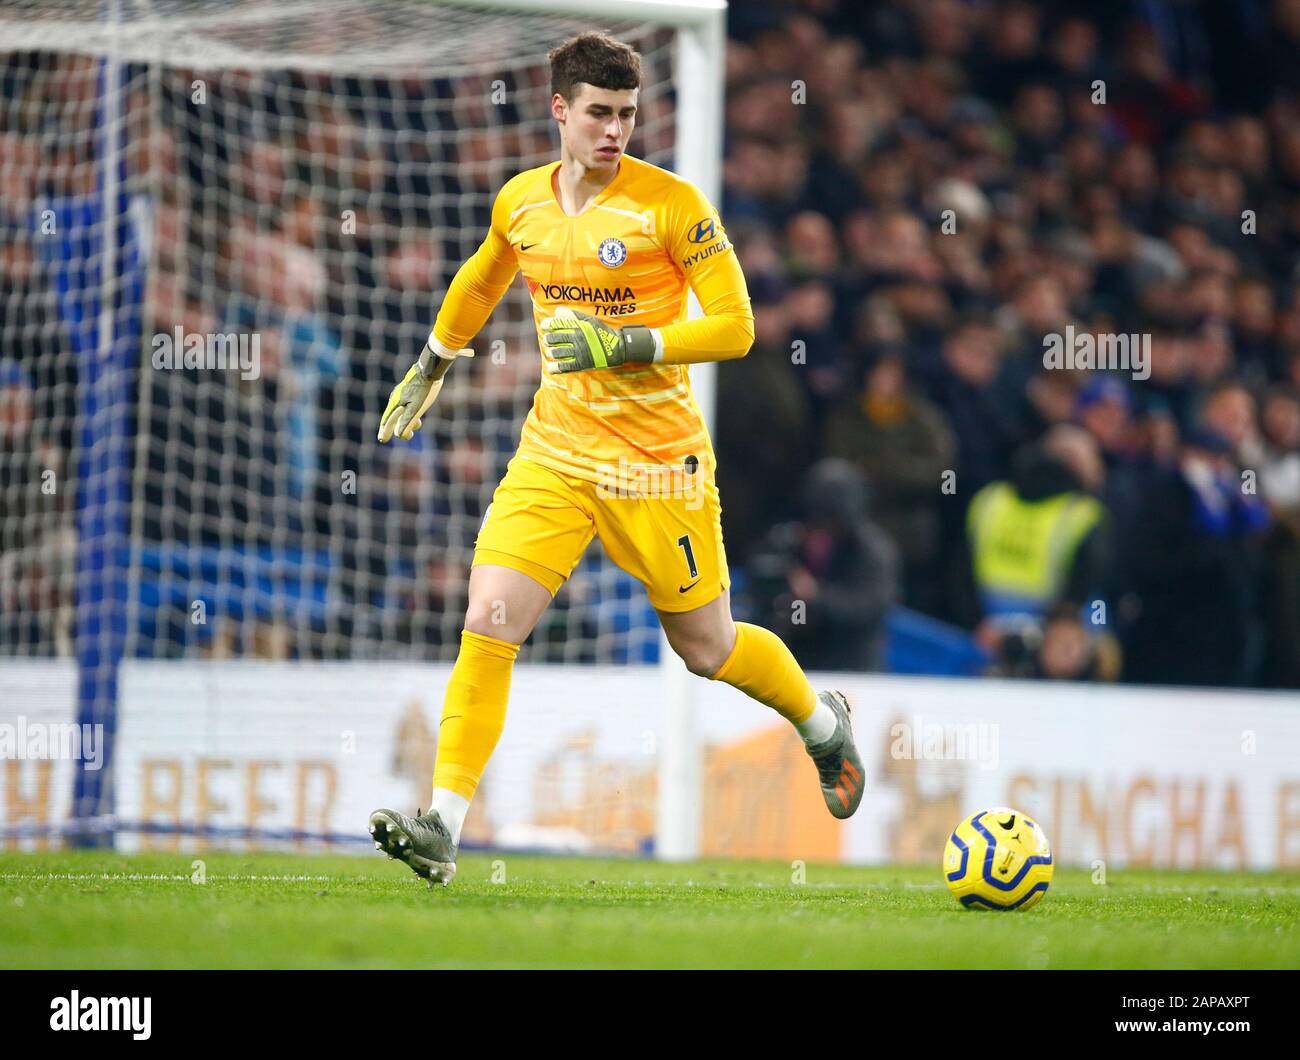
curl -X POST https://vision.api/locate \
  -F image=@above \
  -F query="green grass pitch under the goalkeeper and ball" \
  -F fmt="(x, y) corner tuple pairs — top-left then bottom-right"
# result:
(0, 851), (1300, 968)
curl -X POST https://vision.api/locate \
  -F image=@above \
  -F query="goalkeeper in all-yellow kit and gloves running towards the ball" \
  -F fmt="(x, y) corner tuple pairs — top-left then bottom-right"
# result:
(371, 33), (865, 886)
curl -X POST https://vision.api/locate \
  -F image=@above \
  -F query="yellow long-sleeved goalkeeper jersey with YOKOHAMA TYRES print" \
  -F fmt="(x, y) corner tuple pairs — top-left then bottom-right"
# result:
(434, 155), (754, 481)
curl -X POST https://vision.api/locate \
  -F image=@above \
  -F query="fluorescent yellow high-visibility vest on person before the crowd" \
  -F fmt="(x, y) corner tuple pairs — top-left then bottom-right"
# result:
(966, 483), (1104, 615)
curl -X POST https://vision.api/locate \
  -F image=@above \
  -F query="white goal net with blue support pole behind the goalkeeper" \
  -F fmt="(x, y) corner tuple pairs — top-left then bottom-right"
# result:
(0, 0), (712, 842)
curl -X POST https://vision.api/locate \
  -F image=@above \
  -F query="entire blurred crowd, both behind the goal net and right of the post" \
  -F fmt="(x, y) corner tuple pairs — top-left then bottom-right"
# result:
(0, 0), (1300, 687)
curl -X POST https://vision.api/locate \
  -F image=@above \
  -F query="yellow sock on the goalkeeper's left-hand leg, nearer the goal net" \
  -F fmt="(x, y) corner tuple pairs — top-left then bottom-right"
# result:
(433, 629), (519, 799)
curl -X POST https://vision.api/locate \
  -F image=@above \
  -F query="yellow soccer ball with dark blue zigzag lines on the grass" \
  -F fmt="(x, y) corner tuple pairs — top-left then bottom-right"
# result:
(944, 806), (1052, 909)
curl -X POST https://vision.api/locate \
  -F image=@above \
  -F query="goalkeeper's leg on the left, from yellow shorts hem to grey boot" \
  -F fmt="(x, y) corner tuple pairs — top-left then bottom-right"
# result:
(371, 460), (593, 886)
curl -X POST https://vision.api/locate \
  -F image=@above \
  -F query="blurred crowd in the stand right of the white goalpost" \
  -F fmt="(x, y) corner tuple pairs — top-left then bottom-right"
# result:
(718, 0), (1300, 687)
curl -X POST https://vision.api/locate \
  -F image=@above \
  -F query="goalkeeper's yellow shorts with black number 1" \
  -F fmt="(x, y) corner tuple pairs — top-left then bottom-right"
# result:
(471, 454), (731, 611)
